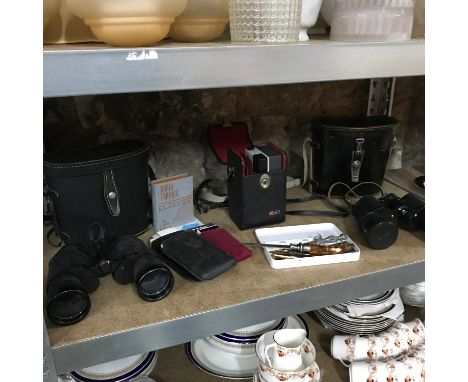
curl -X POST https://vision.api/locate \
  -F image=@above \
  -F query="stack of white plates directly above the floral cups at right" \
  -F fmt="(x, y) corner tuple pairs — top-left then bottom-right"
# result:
(315, 289), (404, 335)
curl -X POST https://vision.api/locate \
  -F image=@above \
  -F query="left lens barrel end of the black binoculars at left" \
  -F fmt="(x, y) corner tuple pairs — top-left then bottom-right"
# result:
(47, 289), (91, 325)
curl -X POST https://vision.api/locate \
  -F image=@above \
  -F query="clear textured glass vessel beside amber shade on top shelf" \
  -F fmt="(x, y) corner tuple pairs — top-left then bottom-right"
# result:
(229, 0), (302, 42)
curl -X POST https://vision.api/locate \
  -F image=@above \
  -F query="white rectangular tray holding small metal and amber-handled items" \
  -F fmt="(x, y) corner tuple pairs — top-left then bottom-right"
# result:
(255, 223), (361, 269)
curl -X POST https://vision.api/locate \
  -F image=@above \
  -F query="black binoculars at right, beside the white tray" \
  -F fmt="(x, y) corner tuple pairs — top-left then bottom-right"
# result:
(352, 193), (425, 249)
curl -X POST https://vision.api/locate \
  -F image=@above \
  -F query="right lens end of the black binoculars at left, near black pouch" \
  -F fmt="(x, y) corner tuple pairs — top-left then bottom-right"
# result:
(135, 266), (174, 301)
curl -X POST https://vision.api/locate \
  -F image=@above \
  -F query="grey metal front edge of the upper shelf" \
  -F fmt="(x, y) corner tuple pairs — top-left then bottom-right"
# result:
(44, 40), (424, 97)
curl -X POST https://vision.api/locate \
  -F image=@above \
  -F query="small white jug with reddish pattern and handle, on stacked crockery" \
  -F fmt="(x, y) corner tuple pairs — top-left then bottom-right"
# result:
(265, 329), (307, 371)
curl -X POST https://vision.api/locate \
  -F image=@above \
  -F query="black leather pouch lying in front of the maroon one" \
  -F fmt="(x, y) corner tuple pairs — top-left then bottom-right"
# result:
(158, 231), (236, 281)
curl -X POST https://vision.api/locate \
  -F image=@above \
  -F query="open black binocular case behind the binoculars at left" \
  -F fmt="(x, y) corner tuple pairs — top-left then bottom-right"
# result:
(44, 140), (151, 244)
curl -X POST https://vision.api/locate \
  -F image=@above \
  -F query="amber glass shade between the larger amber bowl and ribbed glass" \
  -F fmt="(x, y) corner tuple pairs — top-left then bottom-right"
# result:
(169, 0), (229, 42)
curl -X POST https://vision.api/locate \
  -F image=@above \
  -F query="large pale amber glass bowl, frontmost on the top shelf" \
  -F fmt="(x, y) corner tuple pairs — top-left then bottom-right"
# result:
(66, 0), (187, 47)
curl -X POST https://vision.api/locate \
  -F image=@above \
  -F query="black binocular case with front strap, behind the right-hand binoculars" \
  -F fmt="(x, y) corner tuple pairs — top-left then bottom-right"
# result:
(310, 116), (400, 195)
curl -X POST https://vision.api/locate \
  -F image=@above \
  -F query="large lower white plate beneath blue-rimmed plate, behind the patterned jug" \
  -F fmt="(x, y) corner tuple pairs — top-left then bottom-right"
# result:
(185, 316), (308, 379)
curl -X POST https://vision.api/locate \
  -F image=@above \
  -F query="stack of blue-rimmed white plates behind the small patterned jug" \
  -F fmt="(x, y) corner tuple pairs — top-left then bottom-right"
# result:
(185, 316), (308, 379)
